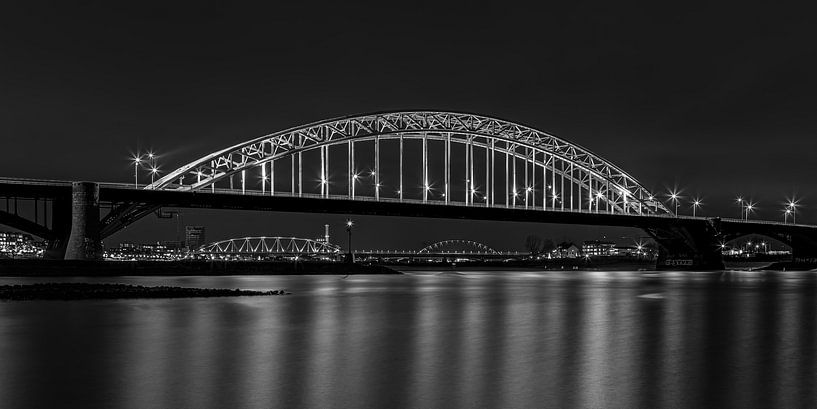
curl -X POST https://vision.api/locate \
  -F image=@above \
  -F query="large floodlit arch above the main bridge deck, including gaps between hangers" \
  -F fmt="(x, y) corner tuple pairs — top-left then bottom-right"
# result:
(146, 111), (670, 215)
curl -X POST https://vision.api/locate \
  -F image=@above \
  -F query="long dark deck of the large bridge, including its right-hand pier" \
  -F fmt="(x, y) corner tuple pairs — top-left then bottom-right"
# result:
(0, 179), (817, 268)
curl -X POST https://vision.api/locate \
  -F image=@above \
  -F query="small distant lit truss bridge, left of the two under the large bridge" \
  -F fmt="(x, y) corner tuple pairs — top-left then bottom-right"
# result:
(193, 237), (341, 256)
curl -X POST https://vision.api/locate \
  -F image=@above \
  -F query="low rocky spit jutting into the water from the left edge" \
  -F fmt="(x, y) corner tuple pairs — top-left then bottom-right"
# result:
(0, 283), (290, 301)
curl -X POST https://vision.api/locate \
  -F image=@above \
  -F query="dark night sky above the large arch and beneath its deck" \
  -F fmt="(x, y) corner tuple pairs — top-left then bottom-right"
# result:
(0, 2), (817, 248)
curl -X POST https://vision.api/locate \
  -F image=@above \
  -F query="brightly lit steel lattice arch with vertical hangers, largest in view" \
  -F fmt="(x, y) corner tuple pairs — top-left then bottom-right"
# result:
(147, 111), (670, 215)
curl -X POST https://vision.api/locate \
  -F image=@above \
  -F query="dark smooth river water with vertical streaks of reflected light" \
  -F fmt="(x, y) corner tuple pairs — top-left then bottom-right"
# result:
(0, 272), (817, 409)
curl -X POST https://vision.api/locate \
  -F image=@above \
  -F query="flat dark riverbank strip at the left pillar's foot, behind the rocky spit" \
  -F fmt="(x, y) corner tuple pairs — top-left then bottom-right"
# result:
(0, 259), (400, 277)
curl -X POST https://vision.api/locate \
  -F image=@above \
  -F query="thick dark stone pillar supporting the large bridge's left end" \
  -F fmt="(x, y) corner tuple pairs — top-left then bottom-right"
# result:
(65, 182), (102, 260)
